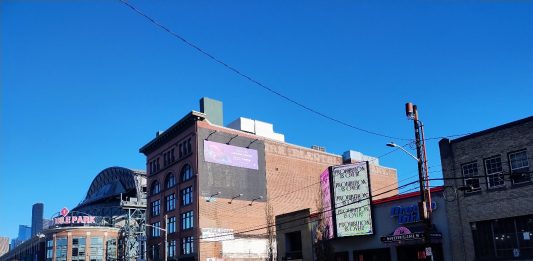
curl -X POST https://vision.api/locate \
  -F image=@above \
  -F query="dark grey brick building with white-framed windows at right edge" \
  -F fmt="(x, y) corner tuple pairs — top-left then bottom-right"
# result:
(439, 117), (533, 260)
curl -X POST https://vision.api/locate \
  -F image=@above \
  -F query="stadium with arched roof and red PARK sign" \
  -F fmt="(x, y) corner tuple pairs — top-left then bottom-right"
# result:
(0, 167), (146, 261)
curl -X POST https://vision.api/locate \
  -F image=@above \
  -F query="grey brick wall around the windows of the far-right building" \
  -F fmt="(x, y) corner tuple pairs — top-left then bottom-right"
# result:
(439, 117), (533, 260)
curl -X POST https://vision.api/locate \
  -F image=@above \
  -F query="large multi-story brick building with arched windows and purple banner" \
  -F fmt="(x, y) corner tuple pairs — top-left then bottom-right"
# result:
(140, 98), (397, 260)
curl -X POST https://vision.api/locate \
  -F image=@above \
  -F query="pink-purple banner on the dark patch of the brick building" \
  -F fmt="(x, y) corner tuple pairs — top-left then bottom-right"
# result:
(204, 140), (259, 170)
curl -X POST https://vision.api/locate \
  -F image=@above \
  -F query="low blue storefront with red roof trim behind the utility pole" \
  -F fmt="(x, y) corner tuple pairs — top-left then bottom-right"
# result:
(330, 188), (451, 261)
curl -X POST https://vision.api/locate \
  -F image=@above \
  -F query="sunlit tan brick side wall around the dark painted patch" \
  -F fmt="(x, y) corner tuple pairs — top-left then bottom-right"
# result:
(199, 136), (398, 260)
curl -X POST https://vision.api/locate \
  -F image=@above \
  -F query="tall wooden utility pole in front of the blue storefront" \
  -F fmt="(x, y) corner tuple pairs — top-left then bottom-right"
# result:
(405, 102), (433, 260)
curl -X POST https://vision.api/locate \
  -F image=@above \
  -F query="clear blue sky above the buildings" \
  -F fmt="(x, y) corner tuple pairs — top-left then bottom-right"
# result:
(0, 0), (533, 238)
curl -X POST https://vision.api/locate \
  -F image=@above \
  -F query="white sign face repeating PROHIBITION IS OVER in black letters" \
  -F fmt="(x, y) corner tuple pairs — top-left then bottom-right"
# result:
(331, 162), (374, 237)
